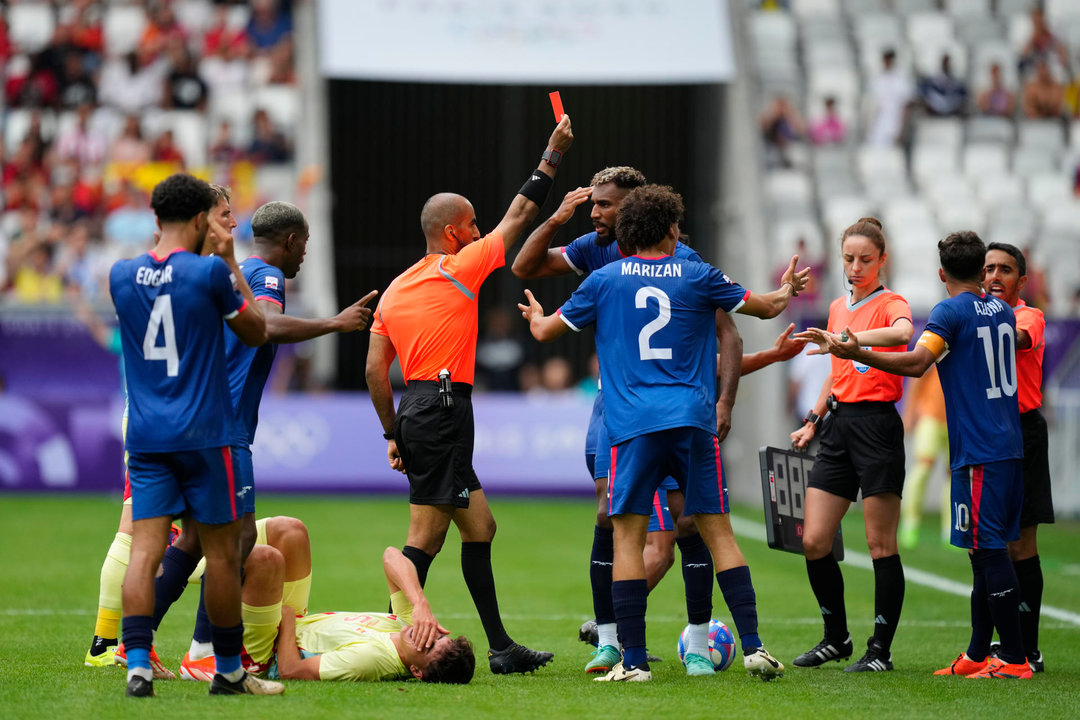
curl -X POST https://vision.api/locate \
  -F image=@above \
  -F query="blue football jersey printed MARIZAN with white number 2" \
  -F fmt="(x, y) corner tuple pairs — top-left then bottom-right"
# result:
(558, 256), (750, 445)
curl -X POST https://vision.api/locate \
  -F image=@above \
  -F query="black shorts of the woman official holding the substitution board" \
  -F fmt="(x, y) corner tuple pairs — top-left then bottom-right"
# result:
(807, 403), (904, 502)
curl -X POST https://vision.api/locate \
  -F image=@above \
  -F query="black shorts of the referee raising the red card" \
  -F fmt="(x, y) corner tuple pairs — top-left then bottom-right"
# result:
(394, 380), (481, 507)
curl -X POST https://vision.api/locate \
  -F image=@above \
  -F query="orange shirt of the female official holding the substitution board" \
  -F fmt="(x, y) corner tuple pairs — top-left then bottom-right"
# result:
(827, 287), (912, 403)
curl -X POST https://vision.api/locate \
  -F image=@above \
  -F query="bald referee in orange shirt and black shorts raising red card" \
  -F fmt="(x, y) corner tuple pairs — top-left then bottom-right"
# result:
(367, 114), (573, 674)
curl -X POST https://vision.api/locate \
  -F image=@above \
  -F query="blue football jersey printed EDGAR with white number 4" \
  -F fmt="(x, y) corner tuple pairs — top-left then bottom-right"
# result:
(109, 250), (244, 452)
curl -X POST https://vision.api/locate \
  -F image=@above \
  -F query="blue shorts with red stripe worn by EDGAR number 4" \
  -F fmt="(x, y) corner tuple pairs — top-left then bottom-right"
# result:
(127, 447), (242, 525)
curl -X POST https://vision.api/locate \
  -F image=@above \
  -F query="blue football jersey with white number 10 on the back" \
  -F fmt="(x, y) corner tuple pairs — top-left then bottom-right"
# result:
(919, 293), (1024, 470)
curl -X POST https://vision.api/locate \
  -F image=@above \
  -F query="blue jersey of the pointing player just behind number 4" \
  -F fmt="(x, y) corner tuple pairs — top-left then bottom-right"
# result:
(225, 257), (285, 447)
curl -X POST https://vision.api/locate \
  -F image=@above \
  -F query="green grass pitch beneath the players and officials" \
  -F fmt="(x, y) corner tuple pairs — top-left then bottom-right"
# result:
(0, 494), (1080, 720)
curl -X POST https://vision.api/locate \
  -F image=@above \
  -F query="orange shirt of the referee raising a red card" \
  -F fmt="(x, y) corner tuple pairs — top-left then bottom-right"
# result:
(372, 231), (507, 384)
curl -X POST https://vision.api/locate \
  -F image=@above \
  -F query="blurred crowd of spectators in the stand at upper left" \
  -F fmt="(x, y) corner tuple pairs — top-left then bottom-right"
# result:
(0, 0), (297, 304)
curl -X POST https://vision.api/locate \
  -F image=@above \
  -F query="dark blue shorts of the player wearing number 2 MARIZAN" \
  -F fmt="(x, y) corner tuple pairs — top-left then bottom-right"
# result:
(608, 427), (729, 517)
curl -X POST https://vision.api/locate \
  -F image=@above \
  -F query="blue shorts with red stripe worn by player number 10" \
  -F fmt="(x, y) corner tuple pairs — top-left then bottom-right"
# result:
(950, 459), (1024, 549)
